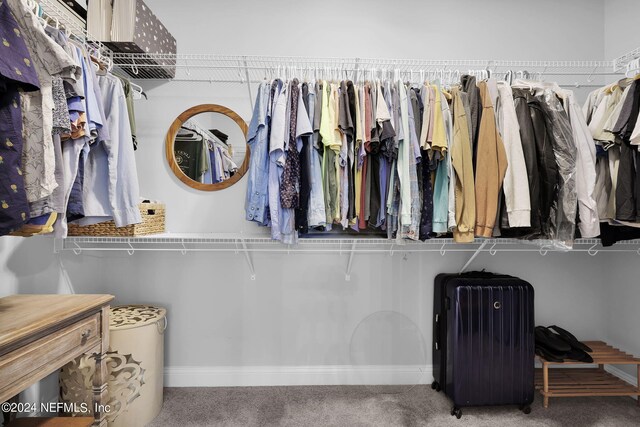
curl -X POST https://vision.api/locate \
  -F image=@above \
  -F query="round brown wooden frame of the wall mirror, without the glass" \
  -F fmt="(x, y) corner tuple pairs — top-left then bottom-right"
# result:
(165, 104), (251, 191)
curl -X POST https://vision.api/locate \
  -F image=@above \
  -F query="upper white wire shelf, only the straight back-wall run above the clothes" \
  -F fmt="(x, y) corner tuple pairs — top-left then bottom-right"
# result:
(113, 52), (618, 84)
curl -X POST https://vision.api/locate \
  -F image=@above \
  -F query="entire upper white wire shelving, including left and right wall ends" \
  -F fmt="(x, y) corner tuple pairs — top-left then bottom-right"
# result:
(33, 0), (640, 86)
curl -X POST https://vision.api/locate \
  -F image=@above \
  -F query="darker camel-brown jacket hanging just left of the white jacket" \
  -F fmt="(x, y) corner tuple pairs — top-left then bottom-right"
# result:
(476, 82), (507, 237)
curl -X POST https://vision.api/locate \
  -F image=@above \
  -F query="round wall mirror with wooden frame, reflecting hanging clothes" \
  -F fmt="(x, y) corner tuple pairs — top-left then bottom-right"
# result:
(165, 104), (249, 191)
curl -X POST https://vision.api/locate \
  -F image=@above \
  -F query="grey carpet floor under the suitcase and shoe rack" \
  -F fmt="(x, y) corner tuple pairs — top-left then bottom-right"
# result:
(149, 386), (640, 427)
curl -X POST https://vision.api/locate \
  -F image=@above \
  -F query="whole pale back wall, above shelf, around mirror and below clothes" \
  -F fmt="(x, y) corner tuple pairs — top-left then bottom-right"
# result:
(0, 0), (632, 385)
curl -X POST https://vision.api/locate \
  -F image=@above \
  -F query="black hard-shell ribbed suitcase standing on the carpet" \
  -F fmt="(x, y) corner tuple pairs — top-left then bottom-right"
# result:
(431, 272), (535, 418)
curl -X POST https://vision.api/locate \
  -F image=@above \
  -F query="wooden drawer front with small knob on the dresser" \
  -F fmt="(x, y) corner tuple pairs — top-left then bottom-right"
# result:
(0, 313), (101, 392)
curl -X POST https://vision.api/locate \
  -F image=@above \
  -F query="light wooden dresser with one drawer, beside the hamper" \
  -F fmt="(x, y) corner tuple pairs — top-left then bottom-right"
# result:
(0, 295), (113, 427)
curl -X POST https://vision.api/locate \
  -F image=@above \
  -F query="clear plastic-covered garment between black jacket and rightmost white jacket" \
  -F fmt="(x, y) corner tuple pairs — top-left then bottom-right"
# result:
(539, 89), (578, 250)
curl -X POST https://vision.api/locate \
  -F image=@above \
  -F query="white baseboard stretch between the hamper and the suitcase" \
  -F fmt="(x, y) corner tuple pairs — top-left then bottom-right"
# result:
(164, 365), (433, 387)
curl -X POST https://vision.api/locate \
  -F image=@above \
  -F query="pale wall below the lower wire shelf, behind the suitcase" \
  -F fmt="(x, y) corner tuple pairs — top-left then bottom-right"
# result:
(1, 239), (611, 385)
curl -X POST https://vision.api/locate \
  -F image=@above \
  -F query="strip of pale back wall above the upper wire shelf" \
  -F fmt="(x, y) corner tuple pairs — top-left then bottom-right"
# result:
(147, 0), (603, 60)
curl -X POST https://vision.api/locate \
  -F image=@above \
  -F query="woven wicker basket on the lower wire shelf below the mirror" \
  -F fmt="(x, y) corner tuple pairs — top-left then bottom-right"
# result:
(67, 203), (165, 237)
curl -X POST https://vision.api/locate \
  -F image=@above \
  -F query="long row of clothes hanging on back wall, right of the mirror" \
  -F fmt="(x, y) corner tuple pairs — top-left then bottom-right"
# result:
(245, 75), (604, 248)
